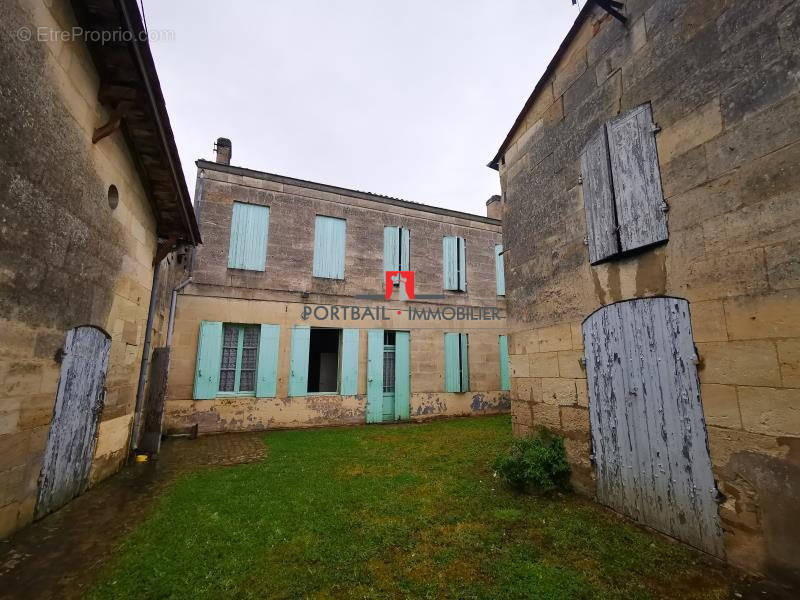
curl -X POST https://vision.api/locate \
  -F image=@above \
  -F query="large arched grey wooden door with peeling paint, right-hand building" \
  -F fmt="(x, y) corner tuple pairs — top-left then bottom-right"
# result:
(583, 298), (724, 557)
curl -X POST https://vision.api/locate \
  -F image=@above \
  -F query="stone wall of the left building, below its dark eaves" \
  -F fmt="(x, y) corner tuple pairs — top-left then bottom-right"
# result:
(0, 0), (182, 537)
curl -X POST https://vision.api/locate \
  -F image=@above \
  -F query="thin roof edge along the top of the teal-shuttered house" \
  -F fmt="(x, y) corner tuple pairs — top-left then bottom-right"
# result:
(195, 158), (503, 226)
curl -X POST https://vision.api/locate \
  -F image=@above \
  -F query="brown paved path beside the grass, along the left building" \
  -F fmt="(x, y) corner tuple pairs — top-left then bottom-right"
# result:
(0, 433), (266, 600)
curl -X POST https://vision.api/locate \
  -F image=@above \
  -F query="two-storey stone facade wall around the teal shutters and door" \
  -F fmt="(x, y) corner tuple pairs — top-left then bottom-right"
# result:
(166, 163), (510, 432)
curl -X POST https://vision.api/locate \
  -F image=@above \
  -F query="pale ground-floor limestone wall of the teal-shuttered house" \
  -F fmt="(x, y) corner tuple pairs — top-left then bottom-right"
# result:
(164, 292), (510, 433)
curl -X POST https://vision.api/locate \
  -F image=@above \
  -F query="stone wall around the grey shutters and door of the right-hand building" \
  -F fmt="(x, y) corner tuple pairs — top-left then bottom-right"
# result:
(500, 0), (800, 578)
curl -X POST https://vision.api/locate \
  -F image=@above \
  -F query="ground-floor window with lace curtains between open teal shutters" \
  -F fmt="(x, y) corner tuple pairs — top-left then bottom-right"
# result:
(219, 323), (260, 392)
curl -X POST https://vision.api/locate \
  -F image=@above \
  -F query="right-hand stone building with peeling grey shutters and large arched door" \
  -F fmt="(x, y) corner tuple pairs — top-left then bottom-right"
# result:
(490, 0), (800, 580)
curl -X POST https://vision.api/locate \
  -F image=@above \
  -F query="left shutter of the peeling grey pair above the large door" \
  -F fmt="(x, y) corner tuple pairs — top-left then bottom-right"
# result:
(581, 125), (619, 264)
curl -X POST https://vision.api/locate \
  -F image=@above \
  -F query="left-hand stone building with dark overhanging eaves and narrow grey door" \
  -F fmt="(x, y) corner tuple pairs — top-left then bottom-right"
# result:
(0, 0), (200, 536)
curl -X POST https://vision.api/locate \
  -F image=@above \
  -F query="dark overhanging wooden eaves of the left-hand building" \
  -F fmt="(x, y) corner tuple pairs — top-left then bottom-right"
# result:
(71, 0), (200, 245)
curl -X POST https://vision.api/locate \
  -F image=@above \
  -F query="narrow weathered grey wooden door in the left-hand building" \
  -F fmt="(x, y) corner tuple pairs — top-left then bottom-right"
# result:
(36, 327), (111, 518)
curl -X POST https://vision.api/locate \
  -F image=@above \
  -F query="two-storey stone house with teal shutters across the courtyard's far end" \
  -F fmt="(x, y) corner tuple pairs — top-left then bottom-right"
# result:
(165, 138), (510, 433)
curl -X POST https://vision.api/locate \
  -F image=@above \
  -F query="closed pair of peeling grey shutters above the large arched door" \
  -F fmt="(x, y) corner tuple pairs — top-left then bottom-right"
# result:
(581, 104), (669, 264)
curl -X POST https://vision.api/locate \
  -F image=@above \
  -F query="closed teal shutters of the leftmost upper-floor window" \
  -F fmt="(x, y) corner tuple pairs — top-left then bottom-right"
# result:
(228, 202), (269, 271)
